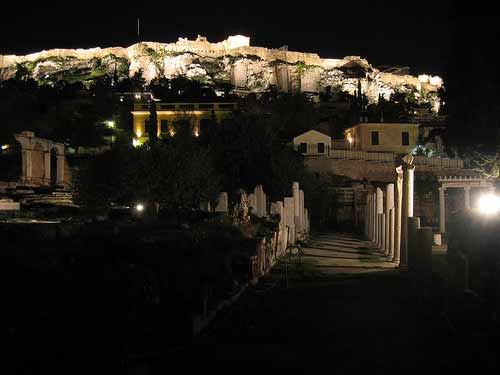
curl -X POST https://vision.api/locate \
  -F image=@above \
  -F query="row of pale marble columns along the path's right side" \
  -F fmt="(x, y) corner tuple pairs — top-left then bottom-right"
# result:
(365, 163), (432, 269)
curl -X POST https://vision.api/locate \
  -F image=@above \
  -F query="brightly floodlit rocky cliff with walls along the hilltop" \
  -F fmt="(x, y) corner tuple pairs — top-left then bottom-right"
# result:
(0, 36), (443, 110)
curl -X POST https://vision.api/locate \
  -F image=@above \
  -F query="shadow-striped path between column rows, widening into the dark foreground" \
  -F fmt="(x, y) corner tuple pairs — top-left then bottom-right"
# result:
(157, 233), (496, 373)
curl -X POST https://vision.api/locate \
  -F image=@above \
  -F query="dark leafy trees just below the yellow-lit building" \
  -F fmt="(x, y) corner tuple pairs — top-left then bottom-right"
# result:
(77, 122), (219, 216)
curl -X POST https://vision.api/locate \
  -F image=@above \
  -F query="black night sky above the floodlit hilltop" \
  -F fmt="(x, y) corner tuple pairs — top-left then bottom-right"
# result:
(0, 0), (451, 74)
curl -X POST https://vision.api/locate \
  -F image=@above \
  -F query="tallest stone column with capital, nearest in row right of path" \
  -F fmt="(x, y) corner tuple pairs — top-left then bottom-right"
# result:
(399, 155), (415, 270)
